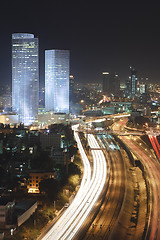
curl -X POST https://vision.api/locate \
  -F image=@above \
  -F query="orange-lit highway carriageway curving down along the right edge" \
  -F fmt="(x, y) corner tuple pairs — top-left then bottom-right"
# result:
(113, 117), (160, 240)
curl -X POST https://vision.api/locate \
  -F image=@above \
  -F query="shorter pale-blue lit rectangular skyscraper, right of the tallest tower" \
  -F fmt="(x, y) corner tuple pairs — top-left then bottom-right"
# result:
(45, 50), (69, 114)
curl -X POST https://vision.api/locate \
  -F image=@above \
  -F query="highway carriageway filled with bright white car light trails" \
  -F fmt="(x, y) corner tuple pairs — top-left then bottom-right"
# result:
(42, 127), (107, 240)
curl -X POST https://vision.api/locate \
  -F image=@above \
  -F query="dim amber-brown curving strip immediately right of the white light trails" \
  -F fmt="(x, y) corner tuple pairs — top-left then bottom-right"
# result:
(84, 135), (125, 240)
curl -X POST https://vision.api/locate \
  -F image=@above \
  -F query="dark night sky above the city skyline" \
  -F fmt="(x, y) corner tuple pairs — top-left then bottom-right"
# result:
(0, 0), (160, 85)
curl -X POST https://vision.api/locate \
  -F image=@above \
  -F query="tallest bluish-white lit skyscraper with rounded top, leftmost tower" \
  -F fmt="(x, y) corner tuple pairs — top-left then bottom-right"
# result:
(12, 33), (39, 125)
